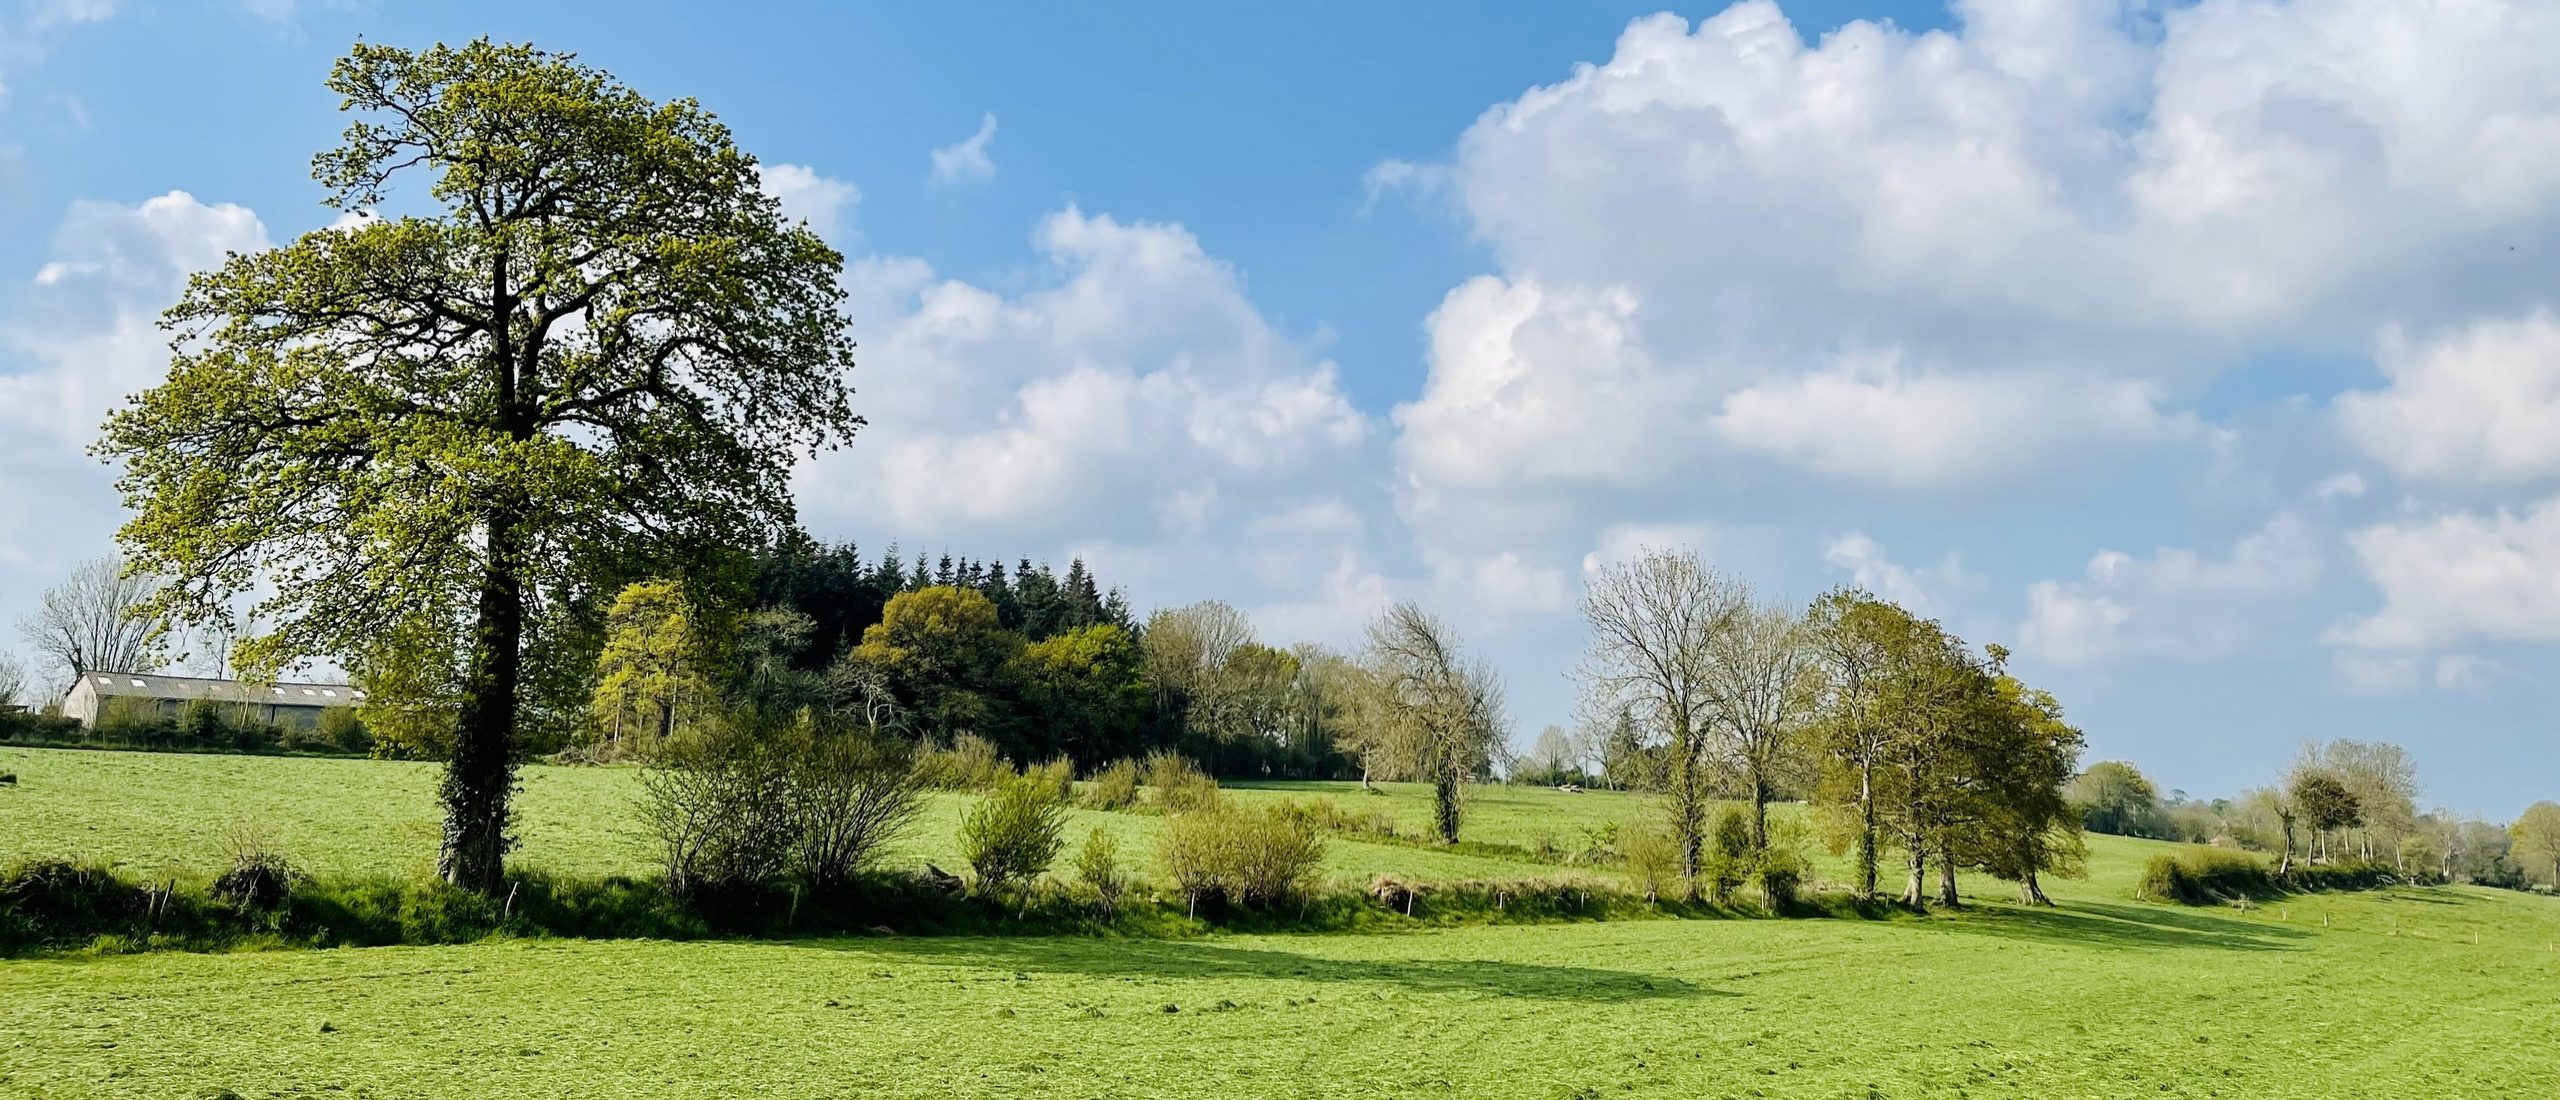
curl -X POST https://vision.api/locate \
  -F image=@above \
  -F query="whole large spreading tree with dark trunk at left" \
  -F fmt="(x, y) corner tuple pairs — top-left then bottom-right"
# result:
(97, 41), (860, 890)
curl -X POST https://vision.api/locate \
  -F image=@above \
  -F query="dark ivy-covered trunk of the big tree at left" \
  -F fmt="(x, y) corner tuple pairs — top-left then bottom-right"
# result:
(435, 512), (525, 893)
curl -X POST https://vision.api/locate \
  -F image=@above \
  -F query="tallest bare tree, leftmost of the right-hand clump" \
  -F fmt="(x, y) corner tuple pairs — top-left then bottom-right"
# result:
(1580, 547), (1748, 893)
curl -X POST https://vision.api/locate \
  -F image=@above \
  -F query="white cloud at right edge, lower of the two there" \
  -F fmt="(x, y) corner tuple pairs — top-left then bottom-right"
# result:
(2330, 501), (2560, 650)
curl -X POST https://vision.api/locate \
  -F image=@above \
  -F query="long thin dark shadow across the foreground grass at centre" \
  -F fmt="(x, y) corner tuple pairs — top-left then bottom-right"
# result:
(812, 936), (1738, 1000)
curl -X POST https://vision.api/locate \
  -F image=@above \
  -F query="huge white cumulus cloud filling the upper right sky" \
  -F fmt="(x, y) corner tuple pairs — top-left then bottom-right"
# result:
(1370, 0), (2560, 526)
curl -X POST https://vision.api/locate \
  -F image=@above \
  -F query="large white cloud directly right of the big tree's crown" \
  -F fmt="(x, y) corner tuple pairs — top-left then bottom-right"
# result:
(799, 207), (1385, 613)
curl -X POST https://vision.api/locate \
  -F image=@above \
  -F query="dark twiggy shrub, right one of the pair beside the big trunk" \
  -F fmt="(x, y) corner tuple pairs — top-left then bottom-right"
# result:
(783, 724), (924, 890)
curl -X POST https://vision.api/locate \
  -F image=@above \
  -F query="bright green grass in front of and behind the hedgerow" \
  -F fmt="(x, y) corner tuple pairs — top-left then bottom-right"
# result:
(0, 752), (2560, 1097)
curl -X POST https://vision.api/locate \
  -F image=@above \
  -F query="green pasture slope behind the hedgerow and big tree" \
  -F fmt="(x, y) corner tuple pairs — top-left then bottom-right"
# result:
(0, 750), (1597, 883)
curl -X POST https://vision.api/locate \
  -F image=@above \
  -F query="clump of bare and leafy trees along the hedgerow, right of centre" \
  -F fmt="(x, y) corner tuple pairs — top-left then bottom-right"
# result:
(1582, 550), (2084, 906)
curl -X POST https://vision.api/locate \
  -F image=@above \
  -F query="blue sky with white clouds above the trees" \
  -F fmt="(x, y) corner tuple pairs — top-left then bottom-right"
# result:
(0, 0), (2560, 816)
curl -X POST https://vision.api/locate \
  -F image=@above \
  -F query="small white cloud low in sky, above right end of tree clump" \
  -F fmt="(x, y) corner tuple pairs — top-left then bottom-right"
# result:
(2017, 514), (2322, 665)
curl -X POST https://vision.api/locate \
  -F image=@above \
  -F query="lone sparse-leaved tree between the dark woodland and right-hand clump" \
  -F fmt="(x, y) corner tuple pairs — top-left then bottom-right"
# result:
(1370, 601), (1510, 844)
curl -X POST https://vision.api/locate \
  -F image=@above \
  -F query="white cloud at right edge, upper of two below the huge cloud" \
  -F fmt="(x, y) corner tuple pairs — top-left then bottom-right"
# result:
(2335, 312), (2560, 486)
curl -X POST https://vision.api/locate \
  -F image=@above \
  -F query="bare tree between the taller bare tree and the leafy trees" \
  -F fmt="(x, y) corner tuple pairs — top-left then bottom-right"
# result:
(1708, 596), (1818, 852)
